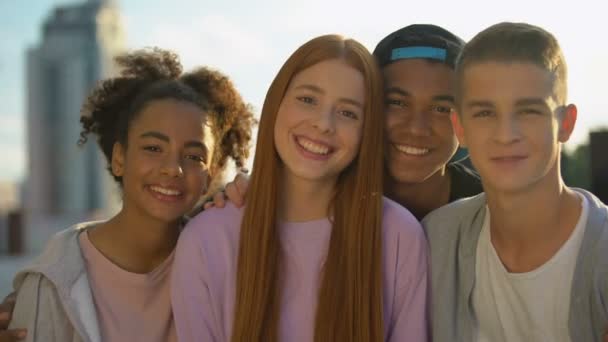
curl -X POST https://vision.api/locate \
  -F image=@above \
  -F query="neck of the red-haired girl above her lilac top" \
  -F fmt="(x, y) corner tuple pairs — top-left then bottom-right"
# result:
(278, 168), (336, 222)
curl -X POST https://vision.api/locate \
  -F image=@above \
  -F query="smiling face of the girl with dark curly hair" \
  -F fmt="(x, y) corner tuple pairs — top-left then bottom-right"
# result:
(112, 99), (213, 223)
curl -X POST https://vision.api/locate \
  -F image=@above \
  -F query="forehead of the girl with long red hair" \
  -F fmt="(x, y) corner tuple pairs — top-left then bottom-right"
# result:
(289, 59), (365, 101)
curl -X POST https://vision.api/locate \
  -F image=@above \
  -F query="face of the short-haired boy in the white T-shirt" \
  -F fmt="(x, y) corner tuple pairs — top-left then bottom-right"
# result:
(453, 62), (576, 192)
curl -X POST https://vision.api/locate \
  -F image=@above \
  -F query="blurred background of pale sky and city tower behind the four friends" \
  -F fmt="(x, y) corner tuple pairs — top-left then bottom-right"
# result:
(0, 0), (608, 297)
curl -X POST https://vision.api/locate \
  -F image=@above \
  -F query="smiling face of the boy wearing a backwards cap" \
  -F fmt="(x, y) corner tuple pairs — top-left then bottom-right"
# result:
(383, 59), (458, 184)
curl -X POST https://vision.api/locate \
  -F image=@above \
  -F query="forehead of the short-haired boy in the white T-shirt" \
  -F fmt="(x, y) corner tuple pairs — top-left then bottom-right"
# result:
(460, 62), (554, 101)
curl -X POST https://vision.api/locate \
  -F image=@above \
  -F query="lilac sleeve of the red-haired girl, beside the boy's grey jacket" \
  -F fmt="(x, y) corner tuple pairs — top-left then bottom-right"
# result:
(387, 223), (429, 342)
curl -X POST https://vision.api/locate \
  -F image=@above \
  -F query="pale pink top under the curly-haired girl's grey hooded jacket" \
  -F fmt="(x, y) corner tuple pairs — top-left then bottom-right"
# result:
(79, 231), (177, 342)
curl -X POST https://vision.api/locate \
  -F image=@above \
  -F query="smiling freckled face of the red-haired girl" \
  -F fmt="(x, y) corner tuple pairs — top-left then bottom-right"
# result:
(274, 59), (365, 188)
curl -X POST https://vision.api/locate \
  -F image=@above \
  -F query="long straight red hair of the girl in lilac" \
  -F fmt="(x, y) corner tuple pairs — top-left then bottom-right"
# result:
(232, 35), (384, 342)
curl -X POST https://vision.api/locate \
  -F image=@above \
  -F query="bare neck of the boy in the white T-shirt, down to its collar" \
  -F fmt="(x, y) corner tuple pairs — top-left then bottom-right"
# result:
(484, 166), (581, 272)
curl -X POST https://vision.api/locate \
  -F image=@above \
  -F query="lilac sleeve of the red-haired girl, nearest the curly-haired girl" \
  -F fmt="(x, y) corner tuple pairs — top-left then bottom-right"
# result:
(171, 227), (220, 342)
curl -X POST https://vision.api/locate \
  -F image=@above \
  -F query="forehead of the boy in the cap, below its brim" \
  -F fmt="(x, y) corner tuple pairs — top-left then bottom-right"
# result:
(382, 59), (454, 93)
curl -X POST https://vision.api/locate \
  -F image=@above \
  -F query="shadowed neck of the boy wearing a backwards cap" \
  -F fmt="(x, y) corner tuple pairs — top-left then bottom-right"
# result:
(384, 167), (451, 220)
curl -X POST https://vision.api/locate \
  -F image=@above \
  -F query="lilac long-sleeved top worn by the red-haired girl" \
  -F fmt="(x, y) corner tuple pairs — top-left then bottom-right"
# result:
(171, 199), (427, 342)
